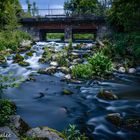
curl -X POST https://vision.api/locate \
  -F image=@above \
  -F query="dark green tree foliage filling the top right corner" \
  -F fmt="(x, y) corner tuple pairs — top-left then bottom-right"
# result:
(108, 0), (140, 32)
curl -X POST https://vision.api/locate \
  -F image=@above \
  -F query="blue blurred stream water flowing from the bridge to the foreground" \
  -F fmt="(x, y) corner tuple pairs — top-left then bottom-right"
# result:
(0, 42), (140, 140)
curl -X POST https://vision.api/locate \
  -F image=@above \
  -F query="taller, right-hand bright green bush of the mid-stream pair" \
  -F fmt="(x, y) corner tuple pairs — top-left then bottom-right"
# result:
(88, 52), (113, 77)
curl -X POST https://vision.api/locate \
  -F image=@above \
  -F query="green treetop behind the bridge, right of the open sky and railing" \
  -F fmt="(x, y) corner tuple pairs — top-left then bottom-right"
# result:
(64, 0), (98, 15)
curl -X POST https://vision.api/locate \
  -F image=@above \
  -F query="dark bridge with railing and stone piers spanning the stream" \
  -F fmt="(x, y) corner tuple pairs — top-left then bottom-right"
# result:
(20, 9), (105, 41)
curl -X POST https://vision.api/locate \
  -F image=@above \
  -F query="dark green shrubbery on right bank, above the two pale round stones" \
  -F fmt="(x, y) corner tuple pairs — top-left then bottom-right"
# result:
(102, 32), (140, 67)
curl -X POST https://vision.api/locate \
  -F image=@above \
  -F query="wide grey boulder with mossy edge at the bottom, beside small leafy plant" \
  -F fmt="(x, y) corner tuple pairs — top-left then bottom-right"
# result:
(26, 127), (66, 140)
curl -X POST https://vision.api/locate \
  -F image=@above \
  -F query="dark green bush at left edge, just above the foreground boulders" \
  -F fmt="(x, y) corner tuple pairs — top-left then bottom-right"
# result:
(0, 99), (16, 126)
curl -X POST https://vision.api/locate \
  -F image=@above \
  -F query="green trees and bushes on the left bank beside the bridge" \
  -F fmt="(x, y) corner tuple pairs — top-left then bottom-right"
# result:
(0, 0), (30, 51)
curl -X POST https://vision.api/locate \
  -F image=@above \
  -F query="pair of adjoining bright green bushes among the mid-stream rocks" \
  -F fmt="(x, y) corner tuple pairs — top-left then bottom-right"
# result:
(72, 52), (113, 79)
